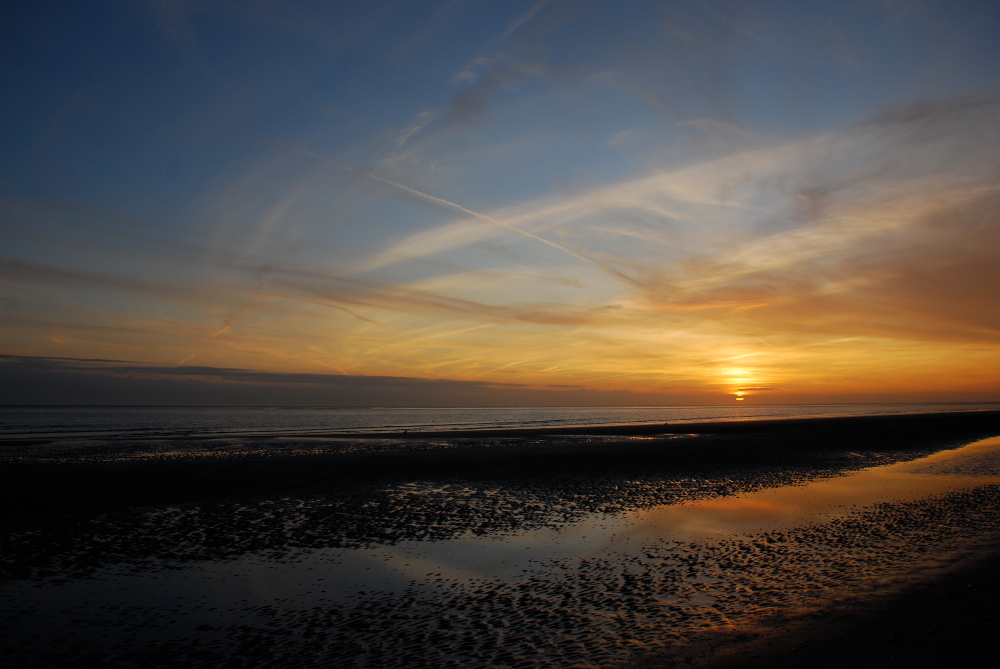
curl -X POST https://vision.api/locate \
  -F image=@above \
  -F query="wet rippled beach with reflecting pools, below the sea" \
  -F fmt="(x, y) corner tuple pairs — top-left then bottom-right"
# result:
(0, 411), (1000, 667)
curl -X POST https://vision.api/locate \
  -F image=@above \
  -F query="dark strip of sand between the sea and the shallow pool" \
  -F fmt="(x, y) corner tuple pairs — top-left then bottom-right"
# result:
(0, 411), (1000, 524)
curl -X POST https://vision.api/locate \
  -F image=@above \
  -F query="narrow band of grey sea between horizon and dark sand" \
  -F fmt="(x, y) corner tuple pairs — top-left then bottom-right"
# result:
(0, 403), (1000, 441)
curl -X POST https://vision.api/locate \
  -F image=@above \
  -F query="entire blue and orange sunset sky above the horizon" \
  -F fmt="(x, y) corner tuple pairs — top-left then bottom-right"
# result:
(0, 0), (1000, 405)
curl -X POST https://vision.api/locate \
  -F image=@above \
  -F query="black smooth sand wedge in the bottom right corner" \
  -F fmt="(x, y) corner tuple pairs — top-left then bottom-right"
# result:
(627, 545), (1000, 669)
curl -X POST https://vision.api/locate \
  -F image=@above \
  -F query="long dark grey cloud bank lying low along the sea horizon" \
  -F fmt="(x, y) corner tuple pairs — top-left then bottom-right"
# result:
(0, 355), (712, 406)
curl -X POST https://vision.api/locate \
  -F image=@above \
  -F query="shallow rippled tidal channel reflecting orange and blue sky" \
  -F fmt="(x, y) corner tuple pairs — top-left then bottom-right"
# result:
(0, 438), (1000, 667)
